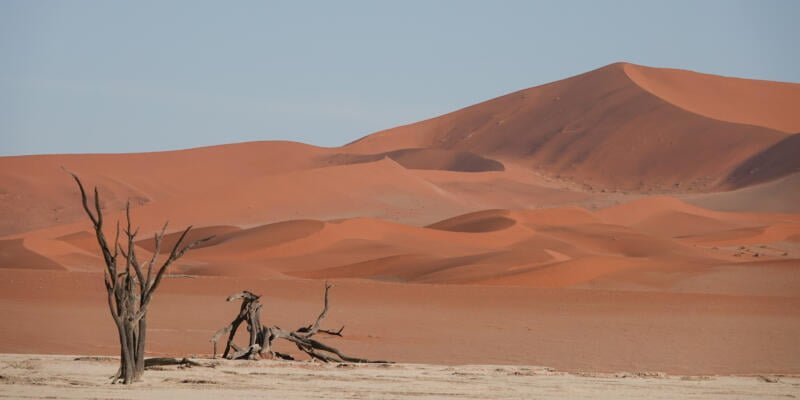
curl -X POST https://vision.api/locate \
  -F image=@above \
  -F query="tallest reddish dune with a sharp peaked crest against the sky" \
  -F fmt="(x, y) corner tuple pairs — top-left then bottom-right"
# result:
(345, 64), (800, 191)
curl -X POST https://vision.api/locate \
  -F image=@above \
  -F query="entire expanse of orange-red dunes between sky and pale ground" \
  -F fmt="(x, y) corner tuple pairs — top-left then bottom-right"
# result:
(0, 63), (800, 373)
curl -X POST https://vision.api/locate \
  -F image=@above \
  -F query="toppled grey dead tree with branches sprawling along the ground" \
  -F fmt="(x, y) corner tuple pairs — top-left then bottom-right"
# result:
(211, 282), (389, 363)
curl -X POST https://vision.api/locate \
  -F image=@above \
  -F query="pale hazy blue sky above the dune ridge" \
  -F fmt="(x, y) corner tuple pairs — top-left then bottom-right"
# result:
(0, 0), (800, 156)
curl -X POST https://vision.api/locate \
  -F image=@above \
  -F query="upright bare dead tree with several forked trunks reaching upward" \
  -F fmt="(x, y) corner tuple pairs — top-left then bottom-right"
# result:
(70, 173), (211, 384)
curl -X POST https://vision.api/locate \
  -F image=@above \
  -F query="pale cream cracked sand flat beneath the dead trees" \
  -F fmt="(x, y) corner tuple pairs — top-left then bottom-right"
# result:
(0, 354), (800, 399)
